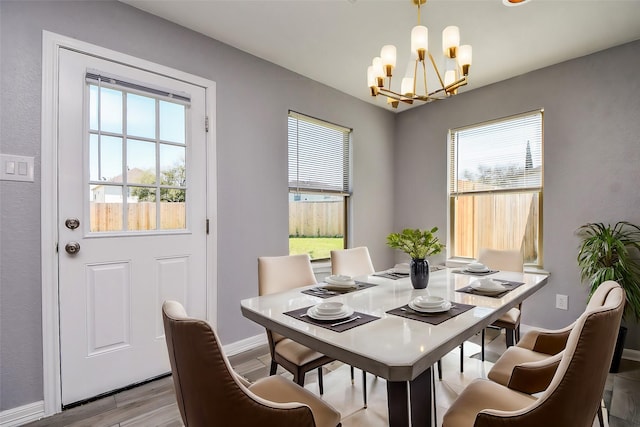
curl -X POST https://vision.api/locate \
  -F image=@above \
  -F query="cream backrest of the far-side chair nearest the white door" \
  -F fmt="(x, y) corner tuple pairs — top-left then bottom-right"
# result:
(258, 254), (317, 295)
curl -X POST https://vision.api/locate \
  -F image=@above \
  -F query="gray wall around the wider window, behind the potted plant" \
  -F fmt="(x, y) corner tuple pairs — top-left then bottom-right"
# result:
(394, 41), (640, 350)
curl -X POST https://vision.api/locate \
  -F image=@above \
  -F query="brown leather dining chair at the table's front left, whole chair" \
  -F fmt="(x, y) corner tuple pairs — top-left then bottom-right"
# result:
(162, 301), (341, 427)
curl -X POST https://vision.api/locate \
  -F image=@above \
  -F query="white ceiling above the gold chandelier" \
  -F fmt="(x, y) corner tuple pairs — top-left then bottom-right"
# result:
(121, 0), (640, 111)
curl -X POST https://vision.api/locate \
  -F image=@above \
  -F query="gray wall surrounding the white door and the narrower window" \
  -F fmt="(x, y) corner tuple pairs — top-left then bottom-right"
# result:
(0, 0), (394, 411)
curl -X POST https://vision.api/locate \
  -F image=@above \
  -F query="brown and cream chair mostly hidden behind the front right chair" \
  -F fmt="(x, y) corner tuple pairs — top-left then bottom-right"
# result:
(487, 281), (617, 426)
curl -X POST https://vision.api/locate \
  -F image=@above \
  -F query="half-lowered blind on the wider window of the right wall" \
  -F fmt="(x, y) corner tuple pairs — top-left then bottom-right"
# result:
(449, 111), (543, 195)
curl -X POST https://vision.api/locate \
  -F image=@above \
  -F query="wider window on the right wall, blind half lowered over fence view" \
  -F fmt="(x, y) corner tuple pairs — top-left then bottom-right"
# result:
(448, 111), (543, 266)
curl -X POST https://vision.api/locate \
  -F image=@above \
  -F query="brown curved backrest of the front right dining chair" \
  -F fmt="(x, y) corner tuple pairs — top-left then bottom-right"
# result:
(474, 282), (625, 427)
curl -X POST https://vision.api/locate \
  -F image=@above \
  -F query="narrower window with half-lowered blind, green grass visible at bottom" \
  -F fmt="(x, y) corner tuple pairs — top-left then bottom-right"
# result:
(288, 111), (351, 260)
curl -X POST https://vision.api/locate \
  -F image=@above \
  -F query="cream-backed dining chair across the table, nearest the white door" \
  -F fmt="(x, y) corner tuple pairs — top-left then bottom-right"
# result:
(258, 254), (335, 394)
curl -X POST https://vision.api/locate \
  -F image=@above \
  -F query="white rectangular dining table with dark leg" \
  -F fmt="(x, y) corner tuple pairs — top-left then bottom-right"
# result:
(240, 268), (547, 427)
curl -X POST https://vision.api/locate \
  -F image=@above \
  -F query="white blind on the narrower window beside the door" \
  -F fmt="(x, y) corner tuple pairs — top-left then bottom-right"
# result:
(288, 111), (351, 194)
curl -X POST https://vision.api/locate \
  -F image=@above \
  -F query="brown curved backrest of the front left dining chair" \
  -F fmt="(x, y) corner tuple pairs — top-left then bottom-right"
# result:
(162, 301), (315, 427)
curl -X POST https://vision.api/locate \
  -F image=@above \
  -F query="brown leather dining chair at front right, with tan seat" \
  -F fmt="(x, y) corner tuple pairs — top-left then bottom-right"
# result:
(442, 283), (625, 427)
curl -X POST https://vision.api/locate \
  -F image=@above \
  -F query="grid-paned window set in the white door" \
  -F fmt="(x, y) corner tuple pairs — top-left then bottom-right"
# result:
(86, 72), (189, 232)
